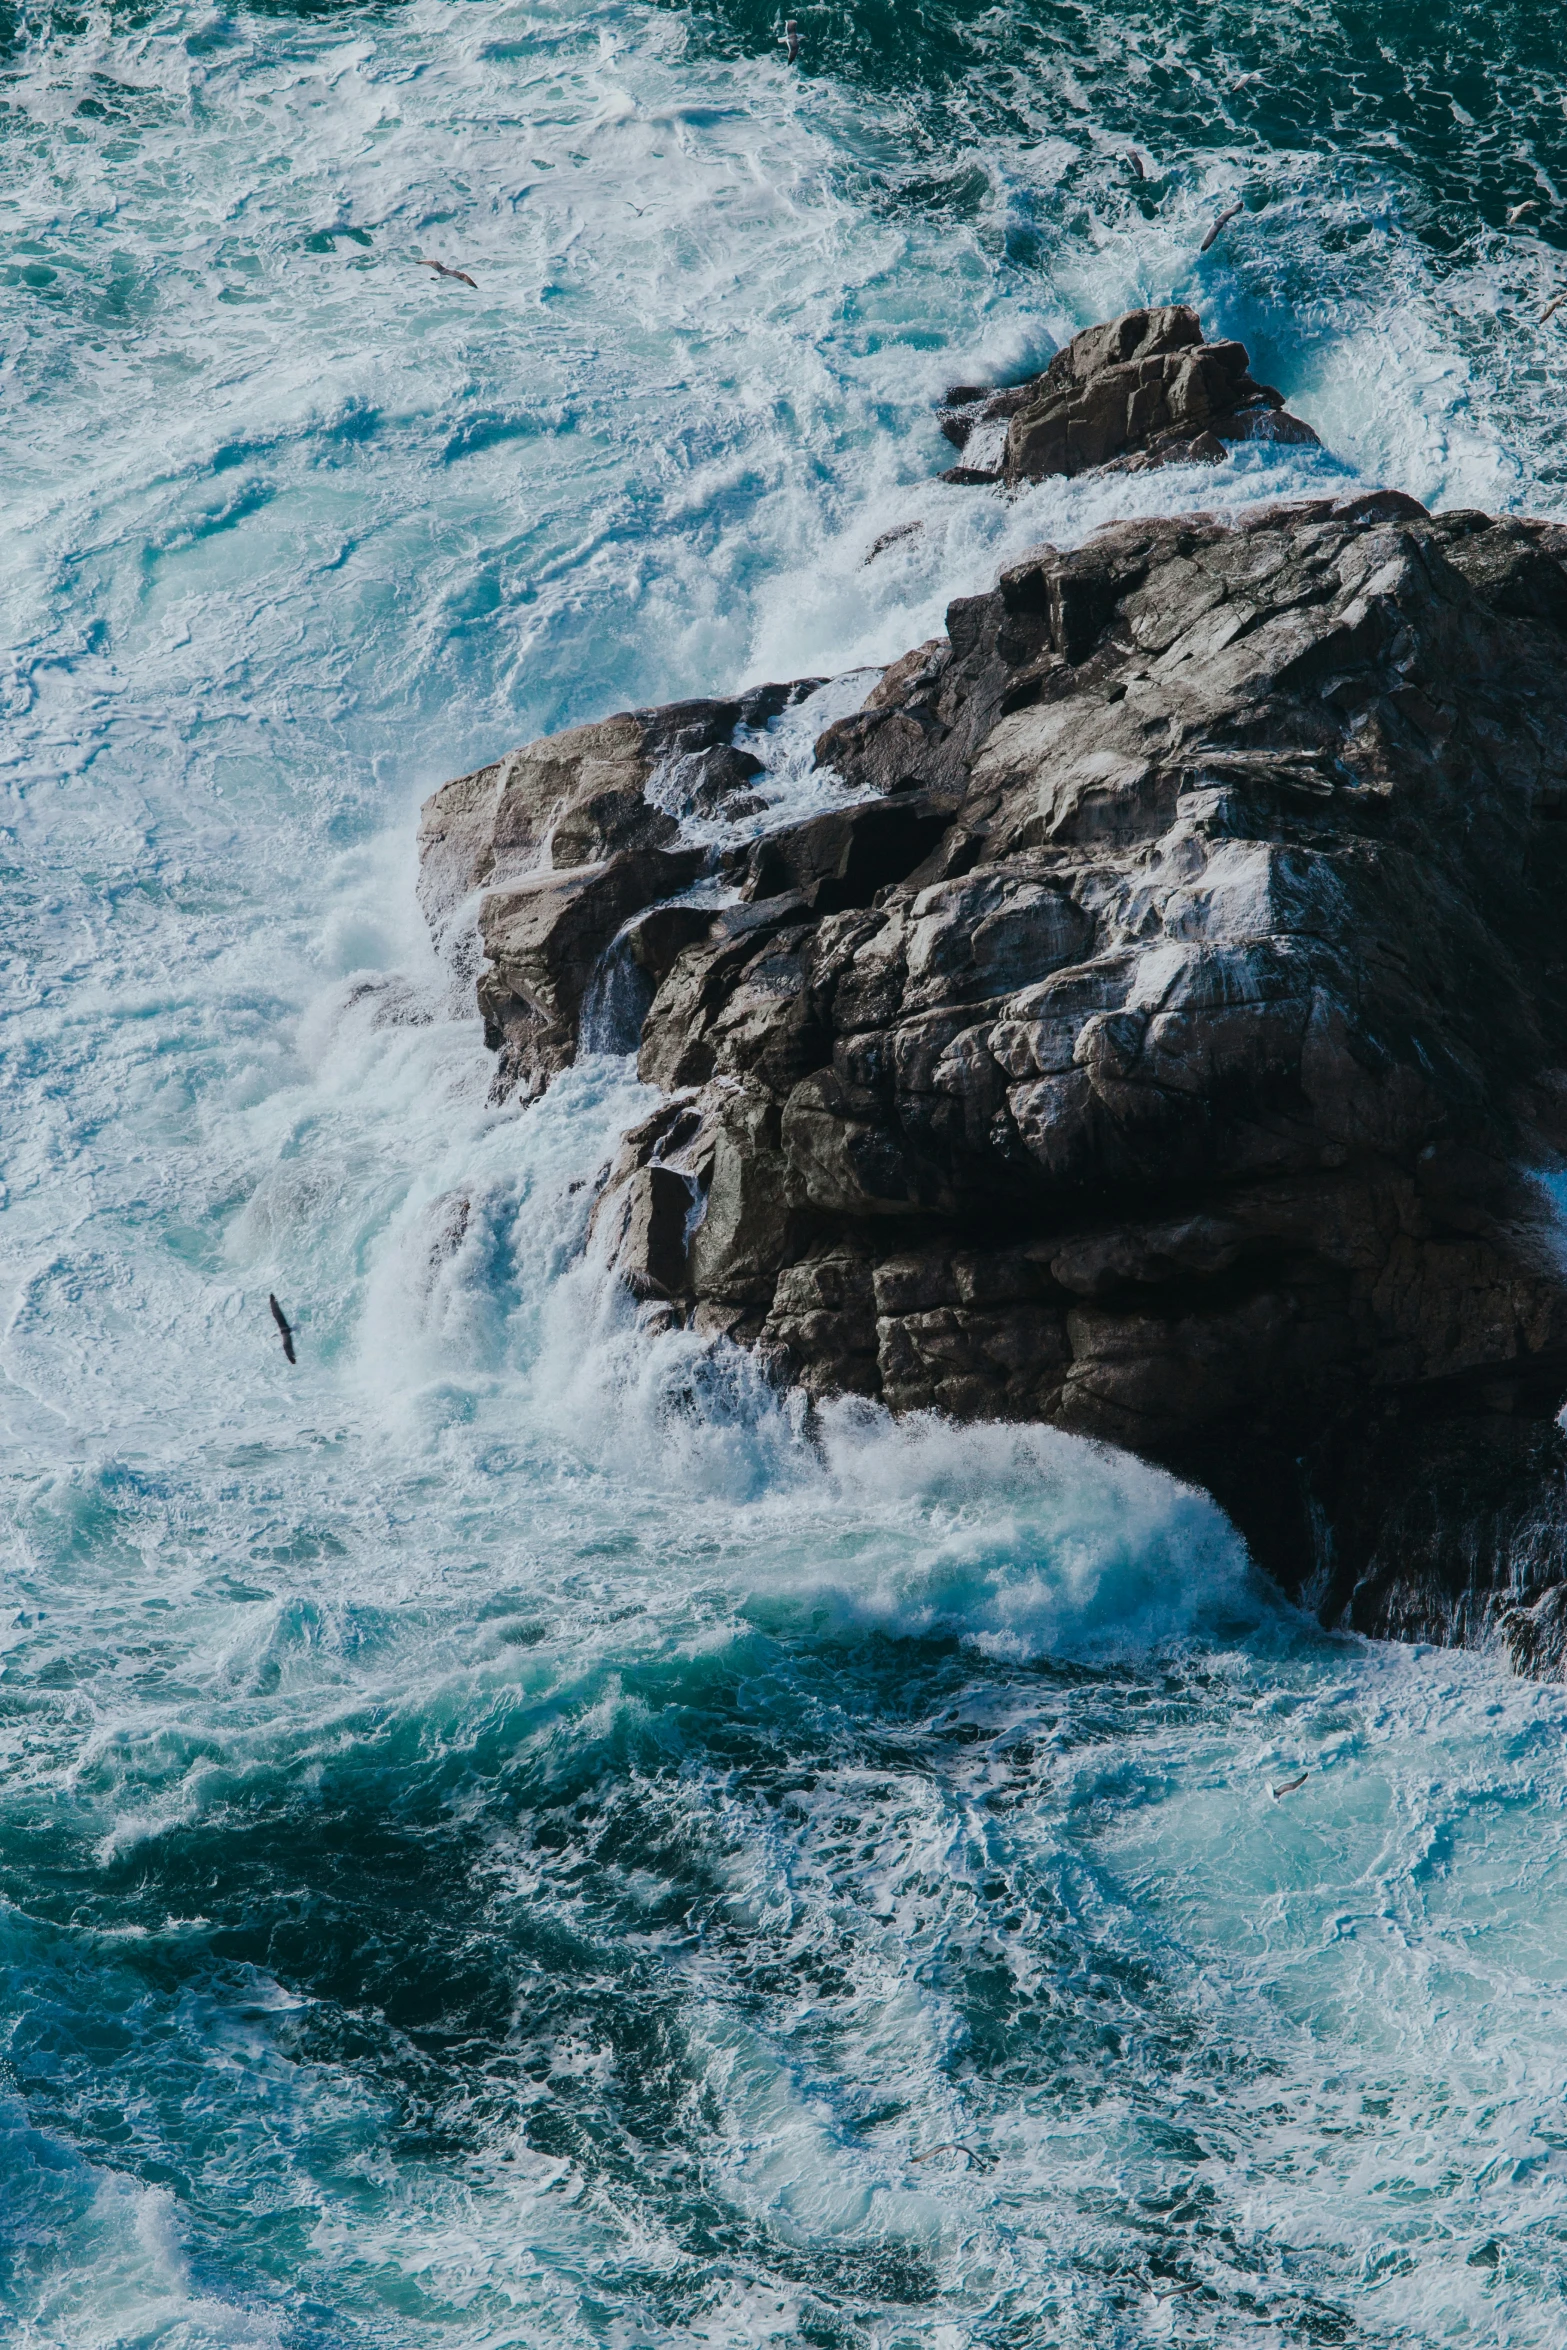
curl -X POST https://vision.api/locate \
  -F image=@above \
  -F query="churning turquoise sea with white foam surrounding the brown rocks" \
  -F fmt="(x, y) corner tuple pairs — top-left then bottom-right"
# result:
(0, 0), (1567, 2350)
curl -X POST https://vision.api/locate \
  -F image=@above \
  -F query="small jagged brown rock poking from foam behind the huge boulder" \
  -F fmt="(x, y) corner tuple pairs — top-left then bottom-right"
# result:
(942, 303), (1316, 484)
